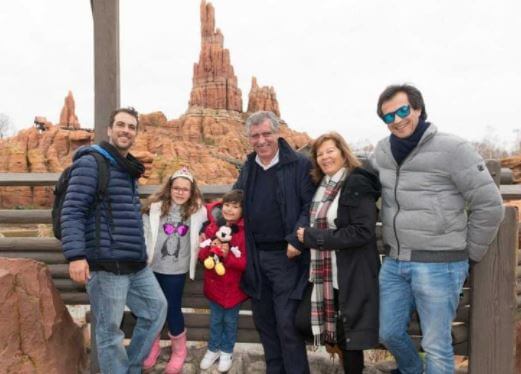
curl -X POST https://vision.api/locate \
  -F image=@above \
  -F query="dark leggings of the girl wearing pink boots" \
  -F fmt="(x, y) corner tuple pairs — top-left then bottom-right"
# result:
(154, 273), (186, 336)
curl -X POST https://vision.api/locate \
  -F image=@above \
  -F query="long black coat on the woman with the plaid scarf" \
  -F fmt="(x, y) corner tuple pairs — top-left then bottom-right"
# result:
(304, 168), (381, 350)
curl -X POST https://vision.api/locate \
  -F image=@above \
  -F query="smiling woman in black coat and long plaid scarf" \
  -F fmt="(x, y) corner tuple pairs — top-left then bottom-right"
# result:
(296, 132), (381, 373)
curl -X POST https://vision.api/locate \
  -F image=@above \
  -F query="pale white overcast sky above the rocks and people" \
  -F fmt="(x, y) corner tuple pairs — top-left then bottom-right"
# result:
(0, 0), (521, 149)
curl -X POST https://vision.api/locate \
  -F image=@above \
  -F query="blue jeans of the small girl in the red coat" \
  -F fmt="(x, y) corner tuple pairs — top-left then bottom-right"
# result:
(208, 301), (240, 353)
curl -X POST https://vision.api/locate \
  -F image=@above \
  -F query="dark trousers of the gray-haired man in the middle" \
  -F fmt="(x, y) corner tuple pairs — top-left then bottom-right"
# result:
(252, 251), (309, 374)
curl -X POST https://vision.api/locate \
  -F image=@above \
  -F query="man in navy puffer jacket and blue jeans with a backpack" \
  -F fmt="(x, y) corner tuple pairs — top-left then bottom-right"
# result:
(61, 108), (166, 374)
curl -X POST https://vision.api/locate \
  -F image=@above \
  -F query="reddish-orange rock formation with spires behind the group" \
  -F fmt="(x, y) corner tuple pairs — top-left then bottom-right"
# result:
(0, 0), (310, 208)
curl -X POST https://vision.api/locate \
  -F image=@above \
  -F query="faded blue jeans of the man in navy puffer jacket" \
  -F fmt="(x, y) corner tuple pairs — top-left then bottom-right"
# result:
(87, 267), (166, 374)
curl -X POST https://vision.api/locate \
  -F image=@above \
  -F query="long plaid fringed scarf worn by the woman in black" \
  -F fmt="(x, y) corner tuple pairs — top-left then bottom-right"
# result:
(309, 170), (348, 346)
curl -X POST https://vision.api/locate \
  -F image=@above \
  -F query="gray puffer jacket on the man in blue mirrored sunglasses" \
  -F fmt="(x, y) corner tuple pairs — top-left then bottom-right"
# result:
(371, 124), (504, 262)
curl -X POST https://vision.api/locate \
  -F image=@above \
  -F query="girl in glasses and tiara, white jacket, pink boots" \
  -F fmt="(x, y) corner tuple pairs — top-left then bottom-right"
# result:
(142, 167), (206, 374)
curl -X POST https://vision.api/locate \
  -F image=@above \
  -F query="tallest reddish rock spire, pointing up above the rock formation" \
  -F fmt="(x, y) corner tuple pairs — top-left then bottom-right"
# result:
(189, 0), (242, 112)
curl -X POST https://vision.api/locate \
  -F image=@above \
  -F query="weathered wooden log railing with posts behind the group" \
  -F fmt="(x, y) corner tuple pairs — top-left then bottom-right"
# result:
(0, 162), (521, 373)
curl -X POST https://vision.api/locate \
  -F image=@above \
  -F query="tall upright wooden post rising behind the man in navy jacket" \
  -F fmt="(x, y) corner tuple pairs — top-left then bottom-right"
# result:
(91, 0), (120, 143)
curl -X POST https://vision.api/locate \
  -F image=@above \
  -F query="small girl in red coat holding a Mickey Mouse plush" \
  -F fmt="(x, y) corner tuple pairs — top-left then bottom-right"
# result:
(199, 190), (248, 373)
